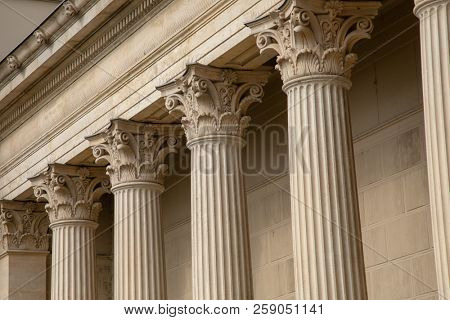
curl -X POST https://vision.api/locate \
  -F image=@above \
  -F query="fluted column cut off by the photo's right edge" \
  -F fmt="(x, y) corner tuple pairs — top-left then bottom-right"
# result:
(415, 0), (450, 299)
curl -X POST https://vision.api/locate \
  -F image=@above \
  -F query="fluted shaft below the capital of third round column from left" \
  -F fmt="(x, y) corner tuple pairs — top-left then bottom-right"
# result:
(189, 136), (252, 300)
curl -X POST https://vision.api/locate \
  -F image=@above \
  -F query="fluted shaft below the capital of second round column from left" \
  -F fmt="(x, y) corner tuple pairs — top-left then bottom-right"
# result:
(113, 182), (166, 300)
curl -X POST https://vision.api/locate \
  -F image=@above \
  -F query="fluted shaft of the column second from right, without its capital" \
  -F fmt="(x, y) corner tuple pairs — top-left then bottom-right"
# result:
(284, 76), (367, 299)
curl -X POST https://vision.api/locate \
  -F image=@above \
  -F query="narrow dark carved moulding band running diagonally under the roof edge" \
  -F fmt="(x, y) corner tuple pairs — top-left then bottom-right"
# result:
(0, 0), (172, 141)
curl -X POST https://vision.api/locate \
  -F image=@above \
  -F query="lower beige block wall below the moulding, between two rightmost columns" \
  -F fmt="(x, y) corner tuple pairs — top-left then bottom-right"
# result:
(356, 113), (436, 299)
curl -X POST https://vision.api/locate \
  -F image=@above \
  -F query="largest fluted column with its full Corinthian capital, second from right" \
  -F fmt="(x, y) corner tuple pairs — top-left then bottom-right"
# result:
(248, 0), (380, 299)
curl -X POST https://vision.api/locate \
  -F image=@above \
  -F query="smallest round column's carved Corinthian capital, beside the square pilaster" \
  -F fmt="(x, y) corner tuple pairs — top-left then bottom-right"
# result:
(30, 164), (110, 223)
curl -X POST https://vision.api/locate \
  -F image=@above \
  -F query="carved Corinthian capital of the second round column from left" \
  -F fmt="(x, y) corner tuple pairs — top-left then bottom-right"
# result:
(86, 119), (183, 187)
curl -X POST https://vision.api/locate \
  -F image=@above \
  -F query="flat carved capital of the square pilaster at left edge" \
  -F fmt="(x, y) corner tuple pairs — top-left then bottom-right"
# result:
(0, 200), (50, 251)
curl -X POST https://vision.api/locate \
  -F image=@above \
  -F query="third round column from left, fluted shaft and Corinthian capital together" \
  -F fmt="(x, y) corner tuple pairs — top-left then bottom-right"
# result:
(158, 65), (268, 299)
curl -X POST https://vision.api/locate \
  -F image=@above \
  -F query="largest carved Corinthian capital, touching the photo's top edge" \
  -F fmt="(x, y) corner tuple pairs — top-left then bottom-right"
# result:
(247, 0), (381, 82)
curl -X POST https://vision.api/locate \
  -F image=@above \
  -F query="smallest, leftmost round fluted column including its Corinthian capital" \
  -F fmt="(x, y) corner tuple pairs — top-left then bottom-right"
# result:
(30, 164), (109, 300)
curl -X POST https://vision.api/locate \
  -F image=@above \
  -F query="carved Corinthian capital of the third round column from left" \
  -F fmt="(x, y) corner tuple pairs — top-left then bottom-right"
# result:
(157, 64), (269, 142)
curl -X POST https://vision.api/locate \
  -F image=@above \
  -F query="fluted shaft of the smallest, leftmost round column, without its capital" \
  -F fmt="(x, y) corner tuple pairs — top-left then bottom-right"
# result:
(50, 220), (98, 300)
